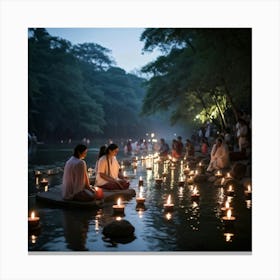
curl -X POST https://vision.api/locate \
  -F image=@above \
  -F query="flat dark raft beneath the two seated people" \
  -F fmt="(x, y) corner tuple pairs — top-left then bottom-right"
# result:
(36, 185), (136, 208)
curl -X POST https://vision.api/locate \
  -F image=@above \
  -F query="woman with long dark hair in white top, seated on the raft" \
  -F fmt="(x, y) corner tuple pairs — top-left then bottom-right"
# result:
(95, 143), (129, 190)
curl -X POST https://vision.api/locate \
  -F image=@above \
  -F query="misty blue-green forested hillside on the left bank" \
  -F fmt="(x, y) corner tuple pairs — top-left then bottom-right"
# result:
(28, 28), (160, 141)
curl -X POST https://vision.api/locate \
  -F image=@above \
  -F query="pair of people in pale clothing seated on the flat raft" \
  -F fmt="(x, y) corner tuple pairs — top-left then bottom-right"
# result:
(62, 143), (129, 201)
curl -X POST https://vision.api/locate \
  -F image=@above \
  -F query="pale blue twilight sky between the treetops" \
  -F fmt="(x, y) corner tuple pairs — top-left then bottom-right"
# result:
(47, 28), (159, 72)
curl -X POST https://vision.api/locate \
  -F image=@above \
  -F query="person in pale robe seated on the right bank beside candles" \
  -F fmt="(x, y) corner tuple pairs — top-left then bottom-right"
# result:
(207, 138), (229, 172)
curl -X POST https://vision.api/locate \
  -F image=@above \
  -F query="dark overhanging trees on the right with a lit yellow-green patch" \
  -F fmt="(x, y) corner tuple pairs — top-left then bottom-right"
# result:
(141, 28), (252, 131)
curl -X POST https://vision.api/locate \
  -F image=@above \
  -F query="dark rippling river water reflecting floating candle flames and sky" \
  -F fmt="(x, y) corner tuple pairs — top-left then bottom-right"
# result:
(28, 145), (252, 253)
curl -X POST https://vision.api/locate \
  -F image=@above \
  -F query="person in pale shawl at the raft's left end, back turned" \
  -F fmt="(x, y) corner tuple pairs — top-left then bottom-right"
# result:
(62, 144), (95, 201)
